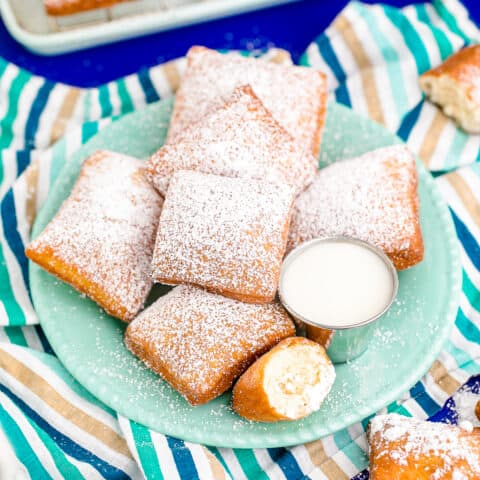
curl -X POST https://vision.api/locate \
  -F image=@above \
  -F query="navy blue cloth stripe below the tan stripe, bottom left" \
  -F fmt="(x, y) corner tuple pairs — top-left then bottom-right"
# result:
(0, 384), (129, 480)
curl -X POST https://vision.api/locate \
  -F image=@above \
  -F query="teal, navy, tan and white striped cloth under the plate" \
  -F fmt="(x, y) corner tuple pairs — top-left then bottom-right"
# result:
(0, 0), (480, 480)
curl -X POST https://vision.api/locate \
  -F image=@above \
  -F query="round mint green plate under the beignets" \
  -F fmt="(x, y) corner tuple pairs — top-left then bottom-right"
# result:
(30, 101), (460, 448)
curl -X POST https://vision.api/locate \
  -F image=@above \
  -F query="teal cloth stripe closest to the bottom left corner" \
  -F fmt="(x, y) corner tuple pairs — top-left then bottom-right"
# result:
(0, 404), (52, 480)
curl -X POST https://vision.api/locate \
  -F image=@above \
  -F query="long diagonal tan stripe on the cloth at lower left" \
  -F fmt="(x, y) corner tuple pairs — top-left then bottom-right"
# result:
(0, 349), (132, 458)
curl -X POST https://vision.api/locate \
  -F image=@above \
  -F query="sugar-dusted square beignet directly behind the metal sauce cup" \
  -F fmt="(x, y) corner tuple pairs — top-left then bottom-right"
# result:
(287, 145), (423, 270)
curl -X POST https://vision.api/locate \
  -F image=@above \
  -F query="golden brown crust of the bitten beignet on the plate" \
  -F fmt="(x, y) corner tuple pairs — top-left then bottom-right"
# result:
(232, 337), (330, 422)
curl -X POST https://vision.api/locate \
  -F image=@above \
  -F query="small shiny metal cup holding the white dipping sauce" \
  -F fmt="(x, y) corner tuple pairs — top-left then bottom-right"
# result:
(278, 237), (398, 363)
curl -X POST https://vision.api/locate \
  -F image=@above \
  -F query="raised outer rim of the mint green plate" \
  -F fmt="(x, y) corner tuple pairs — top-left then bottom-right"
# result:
(29, 99), (461, 448)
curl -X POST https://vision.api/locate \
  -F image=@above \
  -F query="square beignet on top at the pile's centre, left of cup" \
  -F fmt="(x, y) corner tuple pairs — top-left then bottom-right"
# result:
(152, 170), (294, 303)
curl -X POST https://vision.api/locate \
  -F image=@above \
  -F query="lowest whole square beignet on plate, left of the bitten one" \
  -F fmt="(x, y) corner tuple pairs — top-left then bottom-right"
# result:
(125, 285), (295, 405)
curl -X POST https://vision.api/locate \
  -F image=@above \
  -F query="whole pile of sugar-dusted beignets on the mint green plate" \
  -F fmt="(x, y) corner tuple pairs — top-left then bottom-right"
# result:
(26, 47), (423, 422)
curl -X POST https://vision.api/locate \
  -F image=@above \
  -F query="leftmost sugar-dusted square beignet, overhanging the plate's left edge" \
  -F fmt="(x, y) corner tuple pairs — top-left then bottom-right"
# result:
(25, 151), (162, 321)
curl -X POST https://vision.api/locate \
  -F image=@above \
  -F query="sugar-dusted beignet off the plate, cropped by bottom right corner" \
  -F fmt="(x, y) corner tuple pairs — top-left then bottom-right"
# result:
(368, 414), (480, 480)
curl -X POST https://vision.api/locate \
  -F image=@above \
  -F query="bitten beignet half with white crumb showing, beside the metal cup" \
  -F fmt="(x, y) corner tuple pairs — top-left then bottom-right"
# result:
(232, 337), (335, 422)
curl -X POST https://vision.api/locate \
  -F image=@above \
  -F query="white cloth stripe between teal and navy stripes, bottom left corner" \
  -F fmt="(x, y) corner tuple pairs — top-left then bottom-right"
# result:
(0, 392), (63, 479)
